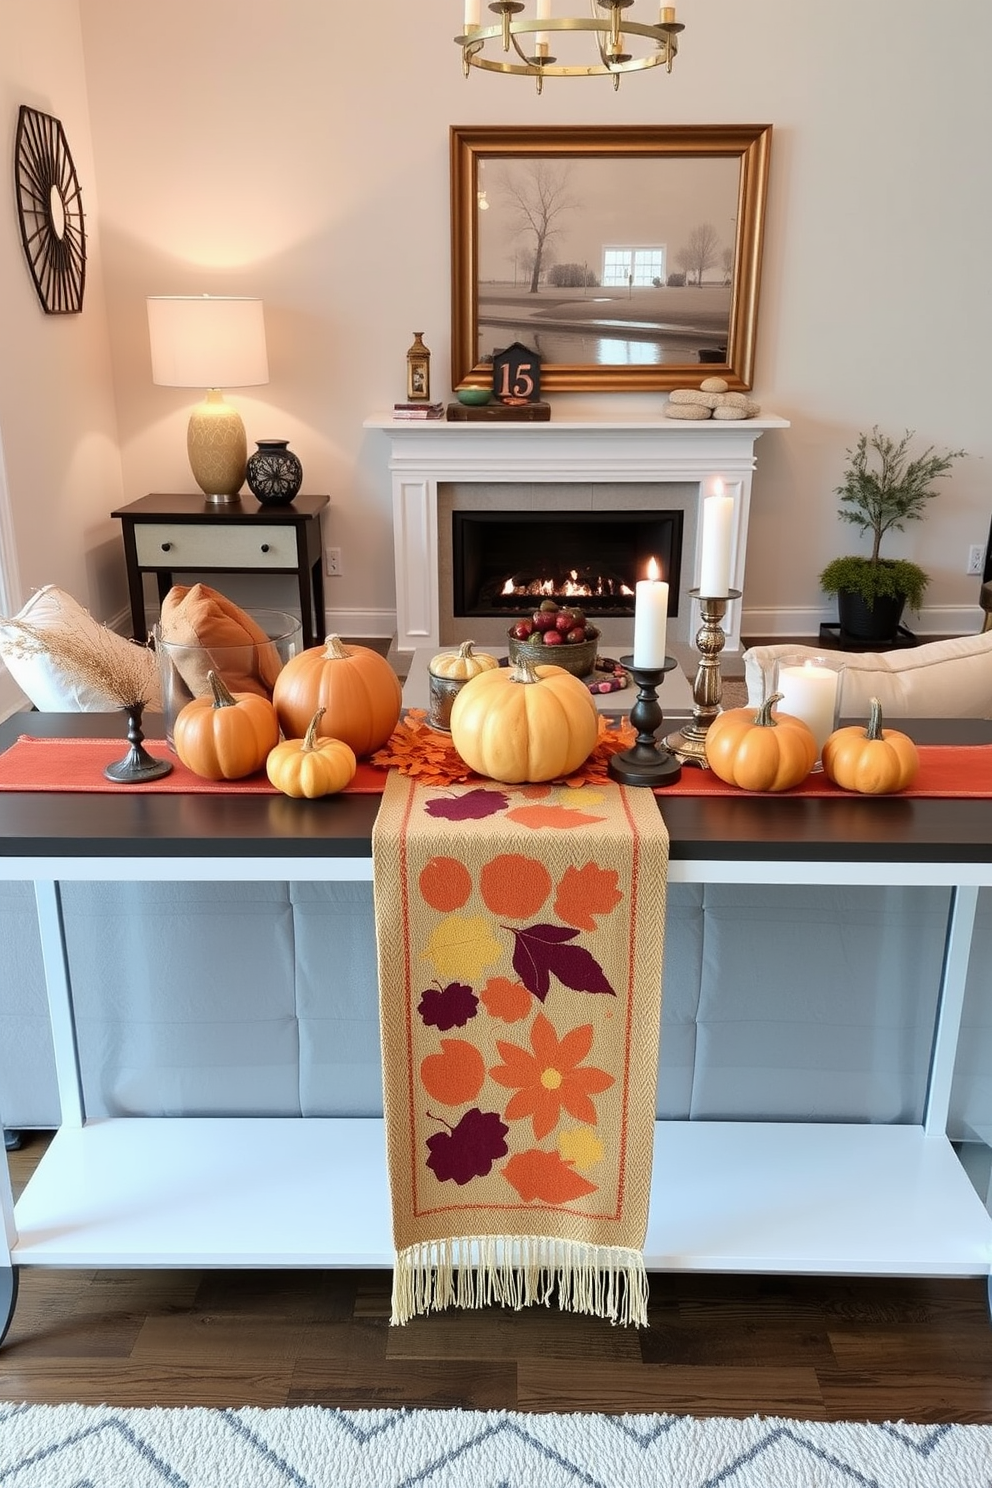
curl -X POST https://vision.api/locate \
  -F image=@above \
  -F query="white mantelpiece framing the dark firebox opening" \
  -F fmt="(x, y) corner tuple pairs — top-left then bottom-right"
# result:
(364, 415), (790, 652)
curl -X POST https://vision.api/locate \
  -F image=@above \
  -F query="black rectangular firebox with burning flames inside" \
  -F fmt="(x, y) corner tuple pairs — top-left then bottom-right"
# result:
(451, 510), (683, 619)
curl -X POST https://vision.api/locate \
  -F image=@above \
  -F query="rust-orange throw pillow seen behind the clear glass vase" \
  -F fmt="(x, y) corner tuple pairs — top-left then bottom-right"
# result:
(159, 583), (283, 698)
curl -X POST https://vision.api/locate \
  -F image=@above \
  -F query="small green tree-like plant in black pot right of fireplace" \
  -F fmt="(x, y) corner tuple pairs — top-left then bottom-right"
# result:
(819, 424), (964, 644)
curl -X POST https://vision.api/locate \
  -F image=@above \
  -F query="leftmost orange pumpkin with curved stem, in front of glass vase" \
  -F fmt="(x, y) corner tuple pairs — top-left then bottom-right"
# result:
(173, 671), (280, 780)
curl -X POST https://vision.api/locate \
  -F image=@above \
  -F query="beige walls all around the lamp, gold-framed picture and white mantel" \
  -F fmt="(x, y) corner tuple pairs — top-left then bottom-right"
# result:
(0, 0), (992, 681)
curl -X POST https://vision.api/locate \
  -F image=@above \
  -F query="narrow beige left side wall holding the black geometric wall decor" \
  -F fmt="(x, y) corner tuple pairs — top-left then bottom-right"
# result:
(0, 0), (125, 711)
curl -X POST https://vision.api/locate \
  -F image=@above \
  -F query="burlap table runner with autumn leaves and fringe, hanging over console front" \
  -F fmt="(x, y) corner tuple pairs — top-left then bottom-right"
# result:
(372, 771), (668, 1324)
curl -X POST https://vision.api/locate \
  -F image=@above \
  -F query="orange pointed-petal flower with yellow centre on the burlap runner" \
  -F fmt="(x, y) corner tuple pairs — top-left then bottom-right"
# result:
(489, 1013), (616, 1141)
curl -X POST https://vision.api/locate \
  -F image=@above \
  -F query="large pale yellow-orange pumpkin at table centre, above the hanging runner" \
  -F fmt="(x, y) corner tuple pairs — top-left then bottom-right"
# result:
(451, 658), (599, 786)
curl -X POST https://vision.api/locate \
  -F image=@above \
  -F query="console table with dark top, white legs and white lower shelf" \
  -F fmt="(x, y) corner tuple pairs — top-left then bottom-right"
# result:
(0, 714), (992, 1338)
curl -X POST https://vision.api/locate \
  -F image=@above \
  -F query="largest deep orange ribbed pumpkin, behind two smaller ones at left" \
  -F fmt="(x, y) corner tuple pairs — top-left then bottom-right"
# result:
(272, 635), (403, 756)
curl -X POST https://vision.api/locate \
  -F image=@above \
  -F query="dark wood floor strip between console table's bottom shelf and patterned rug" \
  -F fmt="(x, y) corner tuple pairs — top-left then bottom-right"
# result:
(0, 1135), (992, 1423)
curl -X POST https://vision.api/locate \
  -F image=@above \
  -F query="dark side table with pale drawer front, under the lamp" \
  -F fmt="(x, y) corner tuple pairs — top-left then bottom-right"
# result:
(110, 494), (329, 647)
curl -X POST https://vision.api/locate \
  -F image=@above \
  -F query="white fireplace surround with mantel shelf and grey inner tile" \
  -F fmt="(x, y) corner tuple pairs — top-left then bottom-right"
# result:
(366, 411), (788, 656)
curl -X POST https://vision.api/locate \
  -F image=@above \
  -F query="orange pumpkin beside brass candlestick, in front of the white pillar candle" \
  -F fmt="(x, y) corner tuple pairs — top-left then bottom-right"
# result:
(705, 692), (817, 790)
